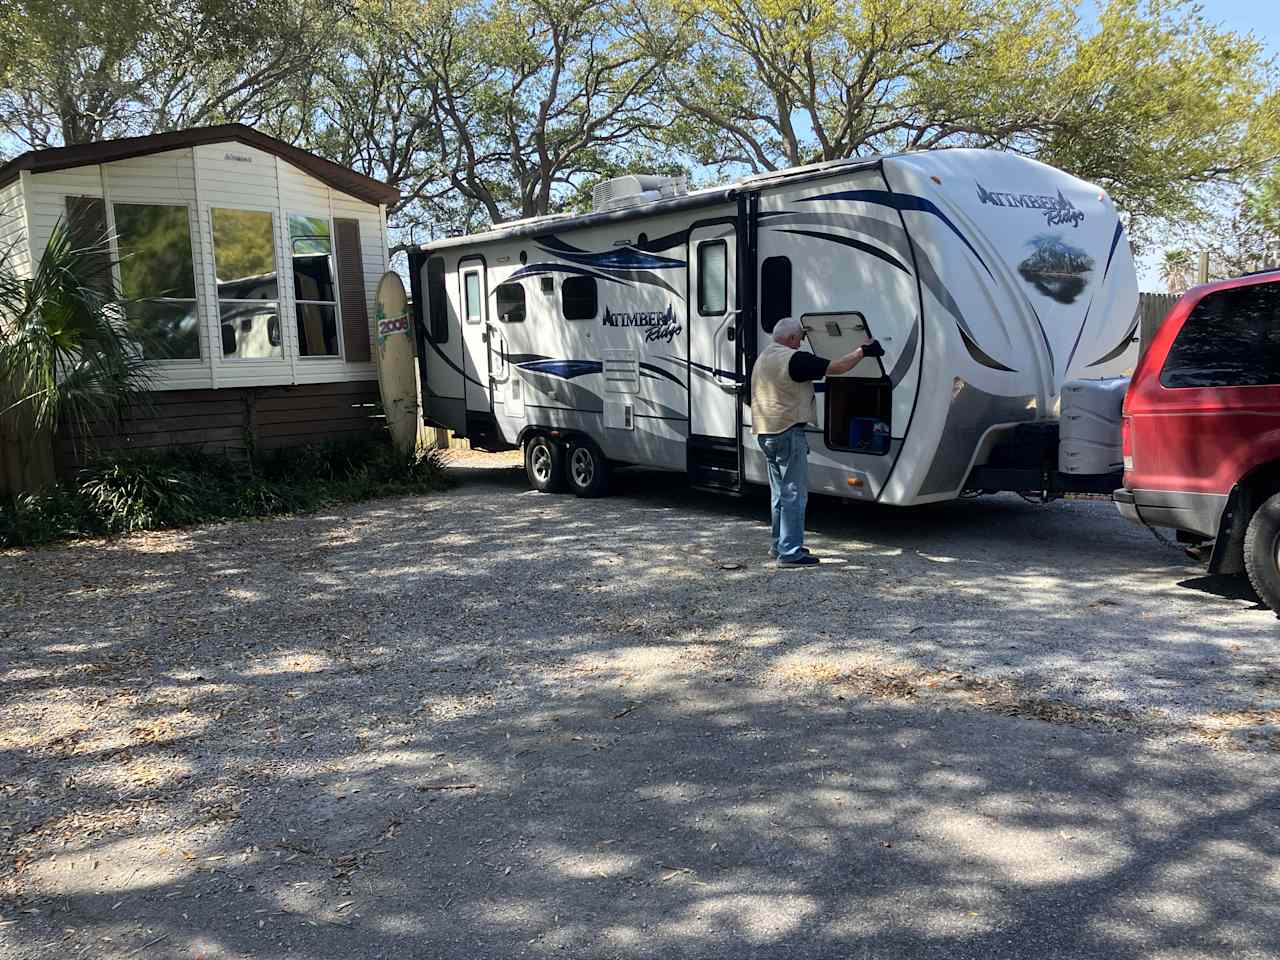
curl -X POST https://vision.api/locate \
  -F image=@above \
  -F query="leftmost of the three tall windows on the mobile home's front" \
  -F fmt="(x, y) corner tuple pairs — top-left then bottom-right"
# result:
(111, 204), (200, 360)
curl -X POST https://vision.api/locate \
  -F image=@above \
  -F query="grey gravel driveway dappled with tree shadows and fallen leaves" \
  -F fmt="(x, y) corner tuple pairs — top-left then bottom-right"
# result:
(0, 456), (1280, 960)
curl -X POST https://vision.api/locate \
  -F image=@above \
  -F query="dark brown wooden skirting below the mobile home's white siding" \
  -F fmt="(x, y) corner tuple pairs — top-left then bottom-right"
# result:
(54, 380), (385, 475)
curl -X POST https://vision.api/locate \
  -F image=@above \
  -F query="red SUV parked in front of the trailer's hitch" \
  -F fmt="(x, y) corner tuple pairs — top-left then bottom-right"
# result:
(1115, 270), (1280, 611)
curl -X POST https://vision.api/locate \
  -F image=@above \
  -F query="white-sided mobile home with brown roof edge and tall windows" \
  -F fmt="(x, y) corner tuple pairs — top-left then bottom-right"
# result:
(0, 124), (399, 489)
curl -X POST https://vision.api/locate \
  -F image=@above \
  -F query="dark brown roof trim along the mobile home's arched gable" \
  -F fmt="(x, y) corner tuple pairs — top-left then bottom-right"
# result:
(0, 123), (399, 206)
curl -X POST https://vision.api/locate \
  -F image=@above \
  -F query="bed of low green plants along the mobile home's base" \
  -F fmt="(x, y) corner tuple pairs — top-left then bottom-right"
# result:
(0, 438), (444, 547)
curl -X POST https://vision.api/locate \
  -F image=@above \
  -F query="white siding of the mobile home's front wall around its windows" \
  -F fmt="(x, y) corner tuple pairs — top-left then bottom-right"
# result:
(18, 142), (388, 390)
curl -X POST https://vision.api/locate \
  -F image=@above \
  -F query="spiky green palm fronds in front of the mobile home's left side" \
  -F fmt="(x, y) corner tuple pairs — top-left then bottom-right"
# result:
(0, 220), (150, 488)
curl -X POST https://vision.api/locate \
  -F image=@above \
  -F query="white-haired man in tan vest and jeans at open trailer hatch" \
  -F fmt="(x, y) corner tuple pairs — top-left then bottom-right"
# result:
(751, 316), (884, 567)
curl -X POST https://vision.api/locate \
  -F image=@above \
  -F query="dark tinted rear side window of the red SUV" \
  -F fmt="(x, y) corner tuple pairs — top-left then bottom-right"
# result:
(1160, 283), (1280, 387)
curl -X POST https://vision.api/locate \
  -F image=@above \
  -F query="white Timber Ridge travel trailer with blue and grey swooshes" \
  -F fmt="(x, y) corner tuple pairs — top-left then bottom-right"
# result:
(410, 150), (1138, 504)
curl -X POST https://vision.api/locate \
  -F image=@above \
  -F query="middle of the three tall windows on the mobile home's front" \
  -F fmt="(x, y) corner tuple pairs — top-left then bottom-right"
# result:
(210, 207), (284, 360)
